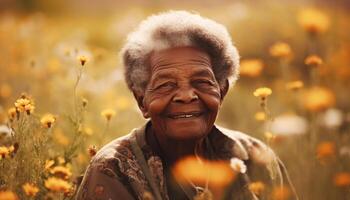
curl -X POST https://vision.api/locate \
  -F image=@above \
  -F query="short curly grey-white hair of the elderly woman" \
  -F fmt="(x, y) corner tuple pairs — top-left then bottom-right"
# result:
(121, 11), (239, 93)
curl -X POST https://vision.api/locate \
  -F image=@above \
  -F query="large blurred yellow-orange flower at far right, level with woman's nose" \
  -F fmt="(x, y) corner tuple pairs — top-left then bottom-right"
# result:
(304, 87), (335, 112)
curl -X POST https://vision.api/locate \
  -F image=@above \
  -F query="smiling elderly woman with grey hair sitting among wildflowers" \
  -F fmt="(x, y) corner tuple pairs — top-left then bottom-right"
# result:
(77, 11), (296, 200)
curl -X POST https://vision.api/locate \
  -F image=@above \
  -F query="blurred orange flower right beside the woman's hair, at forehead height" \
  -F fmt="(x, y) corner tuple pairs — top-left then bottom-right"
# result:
(239, 59), (264, 77)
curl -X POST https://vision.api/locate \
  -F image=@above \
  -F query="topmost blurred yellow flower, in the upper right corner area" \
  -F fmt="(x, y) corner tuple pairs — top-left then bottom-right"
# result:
(298, 8), (329, 34)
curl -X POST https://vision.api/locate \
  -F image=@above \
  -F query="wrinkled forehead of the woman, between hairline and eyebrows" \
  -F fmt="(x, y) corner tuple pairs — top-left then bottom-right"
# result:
(149, 47), (211, 71)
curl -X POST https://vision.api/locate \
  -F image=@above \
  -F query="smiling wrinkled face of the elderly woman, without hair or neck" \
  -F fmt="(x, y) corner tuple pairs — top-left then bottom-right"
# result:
(141, 47), (222, 140)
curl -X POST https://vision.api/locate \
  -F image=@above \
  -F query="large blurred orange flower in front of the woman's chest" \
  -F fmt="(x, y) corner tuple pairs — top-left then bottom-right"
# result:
(173, 157), (235, 187)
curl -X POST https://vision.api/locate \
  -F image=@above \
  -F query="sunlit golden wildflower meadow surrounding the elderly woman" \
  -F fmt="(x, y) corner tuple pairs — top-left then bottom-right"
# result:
(0, 1), (350, 200)
